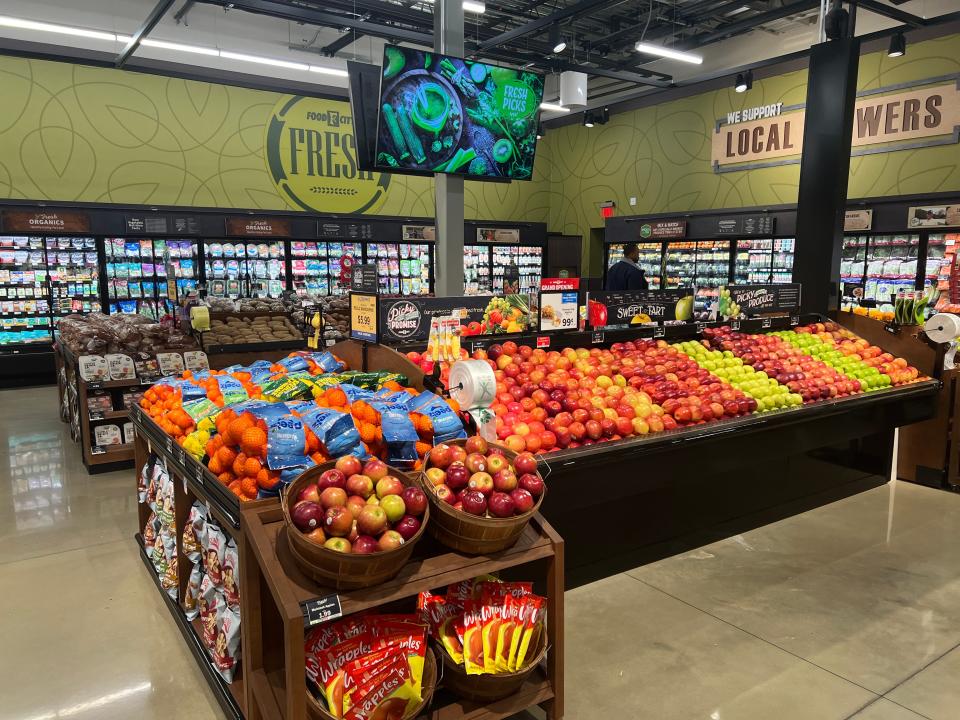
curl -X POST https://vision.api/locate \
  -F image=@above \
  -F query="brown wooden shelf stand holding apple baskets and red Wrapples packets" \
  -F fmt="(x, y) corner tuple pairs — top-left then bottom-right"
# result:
(240, 505), (564, 720)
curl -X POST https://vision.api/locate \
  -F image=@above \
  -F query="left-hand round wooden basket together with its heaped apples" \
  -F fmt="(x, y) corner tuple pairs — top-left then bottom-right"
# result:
(281, 455), (430, 590)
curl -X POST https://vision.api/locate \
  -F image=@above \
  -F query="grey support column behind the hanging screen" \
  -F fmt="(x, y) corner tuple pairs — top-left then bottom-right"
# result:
(433, 0), (464, 296)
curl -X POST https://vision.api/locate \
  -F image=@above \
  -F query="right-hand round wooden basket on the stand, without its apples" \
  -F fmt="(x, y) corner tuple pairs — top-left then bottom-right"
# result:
(420, 440), (547, 556)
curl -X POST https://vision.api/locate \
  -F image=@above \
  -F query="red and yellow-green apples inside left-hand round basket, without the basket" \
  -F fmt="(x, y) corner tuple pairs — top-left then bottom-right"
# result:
(290, 455), (427, 554)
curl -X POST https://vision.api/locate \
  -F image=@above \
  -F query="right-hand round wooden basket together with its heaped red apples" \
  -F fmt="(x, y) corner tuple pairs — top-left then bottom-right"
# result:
(420, 436), (546, 555)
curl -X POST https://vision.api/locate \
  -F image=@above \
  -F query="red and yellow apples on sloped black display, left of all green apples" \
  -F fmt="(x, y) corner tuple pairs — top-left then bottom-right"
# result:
(474, 340), (757, 453)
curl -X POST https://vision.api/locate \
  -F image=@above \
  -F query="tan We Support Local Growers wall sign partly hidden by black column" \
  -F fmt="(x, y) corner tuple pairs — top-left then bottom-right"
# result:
(711, 76), (960, 173)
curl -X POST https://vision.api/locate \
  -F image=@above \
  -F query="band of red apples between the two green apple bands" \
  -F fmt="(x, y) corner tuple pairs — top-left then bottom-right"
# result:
(703, 326), (862, 403)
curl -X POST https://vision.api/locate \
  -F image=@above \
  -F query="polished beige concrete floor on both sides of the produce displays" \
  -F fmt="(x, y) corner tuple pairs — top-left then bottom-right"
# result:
(0, 388), (960, 720)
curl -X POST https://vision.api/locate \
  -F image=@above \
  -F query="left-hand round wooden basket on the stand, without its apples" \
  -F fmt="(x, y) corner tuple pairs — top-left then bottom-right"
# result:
(280, 461), (430, 590)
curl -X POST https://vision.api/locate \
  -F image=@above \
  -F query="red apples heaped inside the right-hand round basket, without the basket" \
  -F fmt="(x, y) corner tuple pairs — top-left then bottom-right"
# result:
(424, 436), (544, 518)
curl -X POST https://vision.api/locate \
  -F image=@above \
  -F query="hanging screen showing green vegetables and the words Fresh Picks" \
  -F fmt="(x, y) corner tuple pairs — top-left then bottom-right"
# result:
(377, 45), (543, 180)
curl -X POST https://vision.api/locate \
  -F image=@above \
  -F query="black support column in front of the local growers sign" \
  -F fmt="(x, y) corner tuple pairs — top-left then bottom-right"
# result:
(793, 38), (860, 312)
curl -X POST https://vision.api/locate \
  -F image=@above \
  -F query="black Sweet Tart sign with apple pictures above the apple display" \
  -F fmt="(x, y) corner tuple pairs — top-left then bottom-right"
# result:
(587, 288), (693, 329)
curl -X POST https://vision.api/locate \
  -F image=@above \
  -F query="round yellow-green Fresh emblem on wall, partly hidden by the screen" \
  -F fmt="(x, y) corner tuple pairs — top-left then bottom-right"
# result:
(264, 95), (390, 213)
